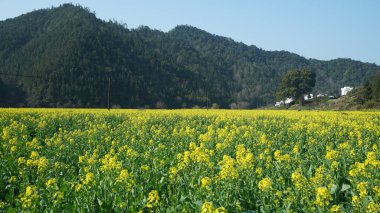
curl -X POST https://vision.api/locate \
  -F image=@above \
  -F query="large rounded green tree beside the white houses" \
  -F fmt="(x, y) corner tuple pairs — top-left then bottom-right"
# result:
(277, 69), (316, 105)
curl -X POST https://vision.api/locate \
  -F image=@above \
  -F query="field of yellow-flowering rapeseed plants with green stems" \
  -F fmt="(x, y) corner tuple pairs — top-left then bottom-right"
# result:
(0, 109), (380, 212)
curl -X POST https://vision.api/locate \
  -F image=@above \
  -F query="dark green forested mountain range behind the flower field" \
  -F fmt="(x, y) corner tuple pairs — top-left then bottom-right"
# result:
(0, 4), (380, 108)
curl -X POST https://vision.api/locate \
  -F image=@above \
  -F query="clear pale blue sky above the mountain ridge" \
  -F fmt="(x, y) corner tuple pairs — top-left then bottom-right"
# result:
(0, 0), (380, 65)
